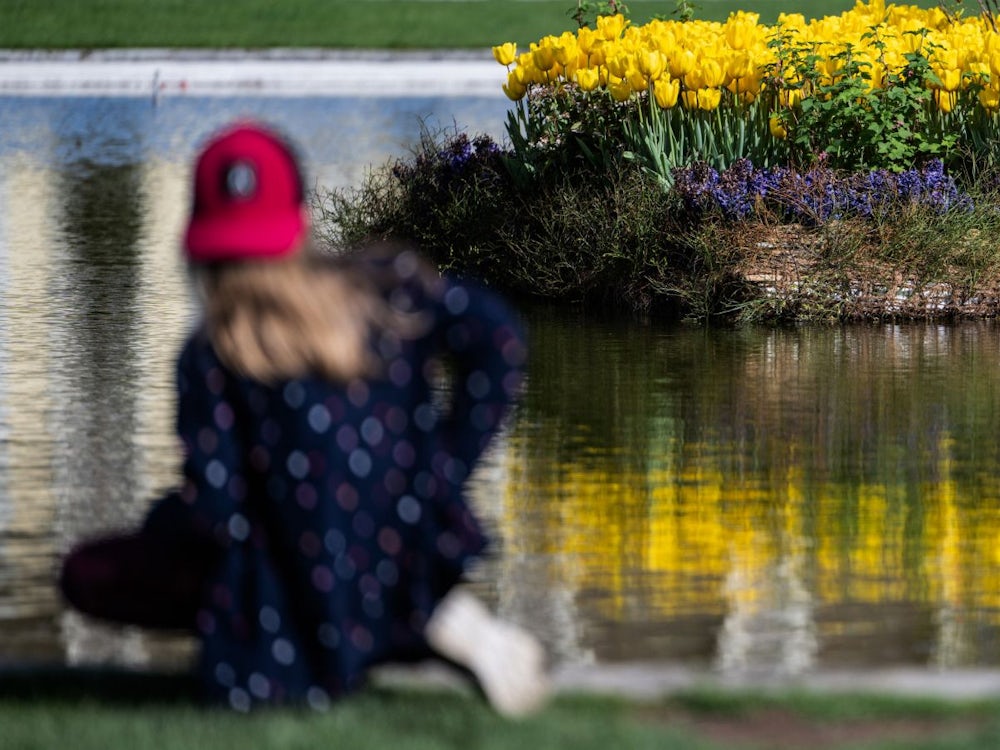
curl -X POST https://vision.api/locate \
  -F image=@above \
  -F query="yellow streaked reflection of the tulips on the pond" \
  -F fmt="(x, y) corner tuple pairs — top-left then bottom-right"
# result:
(501, 424), (1000, 671)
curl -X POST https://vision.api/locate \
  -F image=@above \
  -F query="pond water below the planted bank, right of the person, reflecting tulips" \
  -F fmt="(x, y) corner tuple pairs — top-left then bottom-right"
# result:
(497, 315), (1000, 674)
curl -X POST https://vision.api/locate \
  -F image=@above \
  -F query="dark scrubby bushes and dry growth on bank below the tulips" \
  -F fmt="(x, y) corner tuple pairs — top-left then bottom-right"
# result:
(316, 119), (1000, 322)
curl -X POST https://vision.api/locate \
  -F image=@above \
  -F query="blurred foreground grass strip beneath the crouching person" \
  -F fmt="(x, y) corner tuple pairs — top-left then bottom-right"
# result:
(0, 672), (1000, 750)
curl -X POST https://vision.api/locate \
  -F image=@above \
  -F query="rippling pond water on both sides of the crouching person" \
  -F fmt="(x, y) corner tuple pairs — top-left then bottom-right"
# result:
(0, 92), (1000, 675)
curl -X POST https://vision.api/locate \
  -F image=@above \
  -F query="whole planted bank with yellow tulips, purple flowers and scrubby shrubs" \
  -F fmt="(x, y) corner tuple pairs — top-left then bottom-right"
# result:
(318, 0), (1000, 321)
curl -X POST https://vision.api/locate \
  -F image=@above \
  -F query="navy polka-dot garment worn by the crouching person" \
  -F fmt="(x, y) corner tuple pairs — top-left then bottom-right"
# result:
(168, 264), (525, 710)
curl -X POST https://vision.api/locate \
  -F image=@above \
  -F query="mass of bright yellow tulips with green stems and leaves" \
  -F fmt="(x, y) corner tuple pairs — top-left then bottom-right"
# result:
(494, 0), (1000, 178)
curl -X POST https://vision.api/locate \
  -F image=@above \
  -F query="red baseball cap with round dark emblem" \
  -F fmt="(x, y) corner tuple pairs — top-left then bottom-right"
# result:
(184, 122), (309, 263)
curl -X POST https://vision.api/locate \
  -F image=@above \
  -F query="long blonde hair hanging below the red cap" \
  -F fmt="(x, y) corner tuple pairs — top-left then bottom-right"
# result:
(195, 248), (430, 382)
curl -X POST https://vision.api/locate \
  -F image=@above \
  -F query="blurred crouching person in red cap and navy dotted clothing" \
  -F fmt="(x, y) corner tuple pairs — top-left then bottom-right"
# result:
(60, 122), (546, 716)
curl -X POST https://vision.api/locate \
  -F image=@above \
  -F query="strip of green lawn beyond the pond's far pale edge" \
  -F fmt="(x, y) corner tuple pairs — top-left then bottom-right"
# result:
(0, 0), (935, 49)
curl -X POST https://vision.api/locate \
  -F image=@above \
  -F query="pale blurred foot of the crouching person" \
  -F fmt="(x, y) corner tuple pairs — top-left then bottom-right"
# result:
(424, 590), (549, 718)
